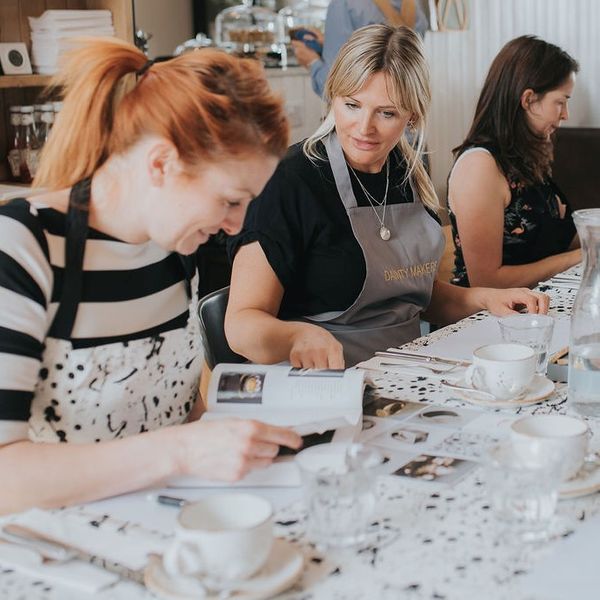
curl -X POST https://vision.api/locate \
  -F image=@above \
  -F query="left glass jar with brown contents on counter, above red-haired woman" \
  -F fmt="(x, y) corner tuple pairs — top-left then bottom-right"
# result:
(215, 0), (287, 67)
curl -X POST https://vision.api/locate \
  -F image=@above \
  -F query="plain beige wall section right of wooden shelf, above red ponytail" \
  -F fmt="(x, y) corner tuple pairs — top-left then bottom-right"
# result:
(133, 0), (194, 58)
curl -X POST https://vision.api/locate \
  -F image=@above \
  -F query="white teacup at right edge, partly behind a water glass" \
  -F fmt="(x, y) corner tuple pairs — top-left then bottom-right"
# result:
(510, 415), (590, 481)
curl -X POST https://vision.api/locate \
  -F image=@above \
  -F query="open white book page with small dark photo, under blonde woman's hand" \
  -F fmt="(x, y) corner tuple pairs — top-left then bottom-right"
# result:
(203, 364), (365, 435)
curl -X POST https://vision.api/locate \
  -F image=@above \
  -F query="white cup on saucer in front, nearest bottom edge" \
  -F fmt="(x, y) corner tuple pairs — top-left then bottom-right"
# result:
(144, 492), (304, 600)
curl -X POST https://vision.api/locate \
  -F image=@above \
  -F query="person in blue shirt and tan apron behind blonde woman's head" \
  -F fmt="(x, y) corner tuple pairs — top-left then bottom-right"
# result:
(292, 0), (428, 96)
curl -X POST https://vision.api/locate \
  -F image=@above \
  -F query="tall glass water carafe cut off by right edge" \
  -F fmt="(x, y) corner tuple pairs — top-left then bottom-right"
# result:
(569, 208), (600, 417)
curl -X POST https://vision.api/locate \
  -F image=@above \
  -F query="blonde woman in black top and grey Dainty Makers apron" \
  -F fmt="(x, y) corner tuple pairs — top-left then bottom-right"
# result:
(225, 25), (548, 368)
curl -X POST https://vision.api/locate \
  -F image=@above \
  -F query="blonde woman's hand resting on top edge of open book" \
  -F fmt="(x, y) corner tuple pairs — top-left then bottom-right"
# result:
(290, 323), (344, 369)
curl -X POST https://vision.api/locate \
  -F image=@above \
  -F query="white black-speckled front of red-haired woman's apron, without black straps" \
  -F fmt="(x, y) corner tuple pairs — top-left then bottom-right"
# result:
(29, 278), (203, 443)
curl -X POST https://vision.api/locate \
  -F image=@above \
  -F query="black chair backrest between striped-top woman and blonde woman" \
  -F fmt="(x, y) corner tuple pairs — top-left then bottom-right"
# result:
(198, 287), (246, 369)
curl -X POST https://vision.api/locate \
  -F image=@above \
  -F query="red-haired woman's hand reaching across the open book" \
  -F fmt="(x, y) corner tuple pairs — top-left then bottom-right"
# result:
(177, 418), (302, 481)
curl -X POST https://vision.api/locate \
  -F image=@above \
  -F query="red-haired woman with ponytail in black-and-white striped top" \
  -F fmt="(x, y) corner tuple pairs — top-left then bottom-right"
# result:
(0, 40), (301, 513)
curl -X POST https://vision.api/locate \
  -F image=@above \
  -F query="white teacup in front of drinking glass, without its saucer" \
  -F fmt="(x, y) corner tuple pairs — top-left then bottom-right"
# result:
(465, 344), (536, 400)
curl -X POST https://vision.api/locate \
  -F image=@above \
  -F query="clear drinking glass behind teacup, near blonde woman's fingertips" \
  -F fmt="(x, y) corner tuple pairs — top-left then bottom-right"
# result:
(498, 313), (554, 375)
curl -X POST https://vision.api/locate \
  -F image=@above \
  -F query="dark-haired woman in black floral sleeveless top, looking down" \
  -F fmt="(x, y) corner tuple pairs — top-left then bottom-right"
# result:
(448, 36), (581, 287)
